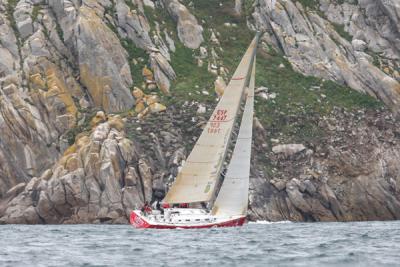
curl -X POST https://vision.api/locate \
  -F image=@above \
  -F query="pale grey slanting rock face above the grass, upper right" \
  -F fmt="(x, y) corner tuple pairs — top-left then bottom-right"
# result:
(253, 0), (400, 112)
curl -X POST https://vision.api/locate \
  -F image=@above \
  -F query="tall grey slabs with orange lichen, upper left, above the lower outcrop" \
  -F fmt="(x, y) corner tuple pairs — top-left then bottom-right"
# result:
(0, 0), (184, 198)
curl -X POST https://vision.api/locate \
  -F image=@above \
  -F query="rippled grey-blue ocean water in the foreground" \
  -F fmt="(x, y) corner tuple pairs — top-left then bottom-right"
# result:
(0, 221), (400, 267)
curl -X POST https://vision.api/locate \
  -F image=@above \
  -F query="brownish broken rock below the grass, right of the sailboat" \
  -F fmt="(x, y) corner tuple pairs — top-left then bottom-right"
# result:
(250, 108), (400, 221)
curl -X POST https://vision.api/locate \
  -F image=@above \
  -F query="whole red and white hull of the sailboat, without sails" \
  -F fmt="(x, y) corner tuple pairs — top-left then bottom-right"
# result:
(130, 209), (246, 229)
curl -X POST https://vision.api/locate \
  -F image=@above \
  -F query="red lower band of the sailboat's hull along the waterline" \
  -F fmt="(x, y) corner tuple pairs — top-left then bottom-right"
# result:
(130, 211), (246, 229)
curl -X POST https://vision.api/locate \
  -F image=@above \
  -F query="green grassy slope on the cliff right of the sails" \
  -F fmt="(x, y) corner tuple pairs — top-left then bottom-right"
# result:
(256, 49), (382, 142)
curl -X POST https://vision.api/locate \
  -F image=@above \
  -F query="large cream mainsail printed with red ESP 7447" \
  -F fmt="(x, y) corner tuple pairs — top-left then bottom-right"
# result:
(163, 36), (258, 203)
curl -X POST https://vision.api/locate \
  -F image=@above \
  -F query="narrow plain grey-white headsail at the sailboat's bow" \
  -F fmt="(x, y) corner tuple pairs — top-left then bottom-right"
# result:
(211, 60), (255, 217)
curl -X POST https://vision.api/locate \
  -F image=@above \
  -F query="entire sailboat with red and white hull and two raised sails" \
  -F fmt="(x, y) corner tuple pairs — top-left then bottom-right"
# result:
(130, 33), (259, 229)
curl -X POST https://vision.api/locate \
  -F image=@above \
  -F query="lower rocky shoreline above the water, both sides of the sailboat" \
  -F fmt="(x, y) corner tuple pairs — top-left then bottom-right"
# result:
(0, 102), (400, 224)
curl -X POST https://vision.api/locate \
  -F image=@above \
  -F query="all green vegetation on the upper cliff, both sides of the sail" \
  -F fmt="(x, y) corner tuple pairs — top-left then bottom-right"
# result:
(103, 0), (382, 148)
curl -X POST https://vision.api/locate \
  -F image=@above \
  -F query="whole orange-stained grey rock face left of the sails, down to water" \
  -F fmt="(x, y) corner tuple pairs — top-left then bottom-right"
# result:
(0, 0), (191, 223)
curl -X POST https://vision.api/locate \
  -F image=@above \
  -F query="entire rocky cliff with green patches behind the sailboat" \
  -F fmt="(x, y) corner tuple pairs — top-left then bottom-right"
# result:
(0, 0), (400, 223)
